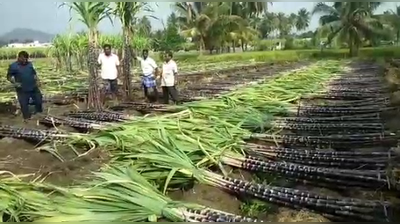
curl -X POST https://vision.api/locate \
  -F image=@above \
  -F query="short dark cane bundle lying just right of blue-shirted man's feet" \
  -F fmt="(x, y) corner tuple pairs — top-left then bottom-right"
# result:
(39, 116), (107, 130)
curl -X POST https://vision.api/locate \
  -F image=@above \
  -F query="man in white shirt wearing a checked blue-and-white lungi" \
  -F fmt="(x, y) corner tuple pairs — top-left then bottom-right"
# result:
(135, 49), (158, 102)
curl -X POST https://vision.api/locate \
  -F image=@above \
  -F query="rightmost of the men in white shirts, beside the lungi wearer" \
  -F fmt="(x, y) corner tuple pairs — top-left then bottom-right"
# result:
(161, 52), (180, 104)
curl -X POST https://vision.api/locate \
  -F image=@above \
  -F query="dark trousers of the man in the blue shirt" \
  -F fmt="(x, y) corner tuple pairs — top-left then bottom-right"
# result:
(17, 87), (43, 119)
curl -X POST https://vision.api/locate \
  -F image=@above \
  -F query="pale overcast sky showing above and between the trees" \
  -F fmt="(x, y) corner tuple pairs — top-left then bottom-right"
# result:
(0, 0), (400, 34)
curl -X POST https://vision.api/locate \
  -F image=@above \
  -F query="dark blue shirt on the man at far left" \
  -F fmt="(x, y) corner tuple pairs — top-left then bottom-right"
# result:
(7, 62), (37, 92)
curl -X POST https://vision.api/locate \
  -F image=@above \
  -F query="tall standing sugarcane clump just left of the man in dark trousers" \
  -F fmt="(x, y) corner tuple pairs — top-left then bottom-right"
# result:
(62, 2), (111, 111)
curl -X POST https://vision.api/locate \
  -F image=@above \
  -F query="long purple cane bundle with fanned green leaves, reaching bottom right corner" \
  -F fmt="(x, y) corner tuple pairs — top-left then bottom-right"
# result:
(111, 128), (395, 221)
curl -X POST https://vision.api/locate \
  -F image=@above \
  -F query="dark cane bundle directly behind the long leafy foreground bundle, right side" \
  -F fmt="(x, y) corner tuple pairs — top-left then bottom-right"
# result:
(222, 155), (399, 190)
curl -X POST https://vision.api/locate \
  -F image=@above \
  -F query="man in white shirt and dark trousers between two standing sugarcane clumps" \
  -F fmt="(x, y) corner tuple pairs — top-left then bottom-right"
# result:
(97, 44), (119, 98)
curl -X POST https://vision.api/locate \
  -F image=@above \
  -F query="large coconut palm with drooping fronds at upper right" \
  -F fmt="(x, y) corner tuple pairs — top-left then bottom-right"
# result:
(313, 2), (384, 56)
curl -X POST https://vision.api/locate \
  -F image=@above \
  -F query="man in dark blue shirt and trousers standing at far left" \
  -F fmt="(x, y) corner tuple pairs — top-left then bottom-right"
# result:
(7, 51), (43, 121)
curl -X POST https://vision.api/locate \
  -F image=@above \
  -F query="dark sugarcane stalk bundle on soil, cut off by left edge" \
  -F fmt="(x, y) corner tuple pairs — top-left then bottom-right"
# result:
(0, 126), (70, 142)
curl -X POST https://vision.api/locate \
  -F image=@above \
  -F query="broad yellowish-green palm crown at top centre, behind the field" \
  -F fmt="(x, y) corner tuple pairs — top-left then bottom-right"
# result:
(174, 2), (267, 52)
